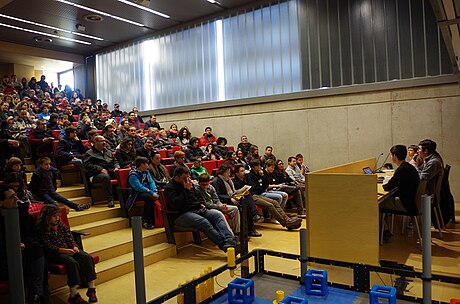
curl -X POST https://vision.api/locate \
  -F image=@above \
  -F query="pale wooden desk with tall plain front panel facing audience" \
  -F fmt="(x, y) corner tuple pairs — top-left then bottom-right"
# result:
(305, 158), (396, 265)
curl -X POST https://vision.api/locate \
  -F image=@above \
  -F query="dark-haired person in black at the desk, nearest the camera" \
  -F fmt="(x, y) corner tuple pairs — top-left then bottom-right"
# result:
(379, 145), (420, 239)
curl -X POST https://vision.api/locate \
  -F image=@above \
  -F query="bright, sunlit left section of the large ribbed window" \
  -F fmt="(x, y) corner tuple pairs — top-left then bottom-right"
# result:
(96, 1), (301, 110)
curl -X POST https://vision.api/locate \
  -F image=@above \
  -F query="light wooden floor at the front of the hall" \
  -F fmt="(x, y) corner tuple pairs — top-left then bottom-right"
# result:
(53, 204), (460, 304)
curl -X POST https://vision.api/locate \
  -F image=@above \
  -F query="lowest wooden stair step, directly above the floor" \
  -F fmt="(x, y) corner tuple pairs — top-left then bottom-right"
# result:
(96, 243), (176, 284)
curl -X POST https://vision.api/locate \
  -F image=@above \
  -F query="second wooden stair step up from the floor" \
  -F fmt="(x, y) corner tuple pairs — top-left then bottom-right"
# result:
(83, 228), (166, 261)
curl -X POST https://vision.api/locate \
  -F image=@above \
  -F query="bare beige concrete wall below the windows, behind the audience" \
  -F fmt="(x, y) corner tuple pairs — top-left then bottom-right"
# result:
(157, 84), (460, 201)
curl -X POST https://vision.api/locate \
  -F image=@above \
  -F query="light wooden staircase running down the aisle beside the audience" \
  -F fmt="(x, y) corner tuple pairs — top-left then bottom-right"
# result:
(25, 159), (177, 303)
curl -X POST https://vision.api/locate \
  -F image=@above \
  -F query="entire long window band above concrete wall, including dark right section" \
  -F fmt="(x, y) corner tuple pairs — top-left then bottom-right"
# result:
(96, 0), (452, 110)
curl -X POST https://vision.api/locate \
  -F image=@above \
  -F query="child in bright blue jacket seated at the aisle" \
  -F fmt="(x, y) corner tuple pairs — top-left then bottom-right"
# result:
(126, 156), (158, 229)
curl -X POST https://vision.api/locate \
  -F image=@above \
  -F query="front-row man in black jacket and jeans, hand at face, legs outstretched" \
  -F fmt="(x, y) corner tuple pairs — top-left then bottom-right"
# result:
(165, 166), (236, 252)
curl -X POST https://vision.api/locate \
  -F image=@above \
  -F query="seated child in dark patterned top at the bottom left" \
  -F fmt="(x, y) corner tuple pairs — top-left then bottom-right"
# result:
(38, 205), (97, 304)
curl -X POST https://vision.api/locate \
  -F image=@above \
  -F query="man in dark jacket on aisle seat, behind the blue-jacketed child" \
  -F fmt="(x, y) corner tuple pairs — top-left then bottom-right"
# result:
(83, 135), (120, 208)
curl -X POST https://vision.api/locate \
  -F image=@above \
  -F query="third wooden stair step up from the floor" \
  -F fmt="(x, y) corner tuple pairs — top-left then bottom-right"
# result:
(68, 205), (121, 227)
